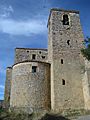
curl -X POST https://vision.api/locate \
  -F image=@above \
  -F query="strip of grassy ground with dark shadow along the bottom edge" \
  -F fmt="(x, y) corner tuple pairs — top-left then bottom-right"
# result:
(0, 109), (90, 120)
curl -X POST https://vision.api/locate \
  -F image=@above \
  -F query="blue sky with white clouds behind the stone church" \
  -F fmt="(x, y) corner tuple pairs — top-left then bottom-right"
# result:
(0, 0), (90, 99)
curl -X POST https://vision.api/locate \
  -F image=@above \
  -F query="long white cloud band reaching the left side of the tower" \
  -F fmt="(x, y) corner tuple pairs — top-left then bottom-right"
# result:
(0, 19), (46, 36)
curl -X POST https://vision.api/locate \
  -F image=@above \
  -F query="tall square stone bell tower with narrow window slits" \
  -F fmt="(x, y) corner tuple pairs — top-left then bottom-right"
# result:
(48, 9), (84, 112)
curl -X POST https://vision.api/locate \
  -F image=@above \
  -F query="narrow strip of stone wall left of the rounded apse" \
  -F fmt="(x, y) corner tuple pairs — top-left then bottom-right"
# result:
(4, 67), (12, 108)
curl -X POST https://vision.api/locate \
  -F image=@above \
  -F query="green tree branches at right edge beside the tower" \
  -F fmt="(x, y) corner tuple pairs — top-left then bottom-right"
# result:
(81, 37), (90, 61)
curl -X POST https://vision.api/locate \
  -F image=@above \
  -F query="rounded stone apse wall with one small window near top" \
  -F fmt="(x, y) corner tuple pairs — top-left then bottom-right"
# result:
(10, 62), (50, 110)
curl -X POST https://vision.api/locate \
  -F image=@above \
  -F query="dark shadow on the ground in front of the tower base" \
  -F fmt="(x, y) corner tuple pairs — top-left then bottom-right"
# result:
(41, 114), (69, 120)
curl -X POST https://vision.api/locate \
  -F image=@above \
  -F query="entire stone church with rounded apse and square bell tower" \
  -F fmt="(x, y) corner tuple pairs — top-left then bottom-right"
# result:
(4, 8), (90, 112)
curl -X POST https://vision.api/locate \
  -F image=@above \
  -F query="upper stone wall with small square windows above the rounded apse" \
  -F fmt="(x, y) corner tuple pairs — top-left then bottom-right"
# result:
(15, 48), (48, 63)
